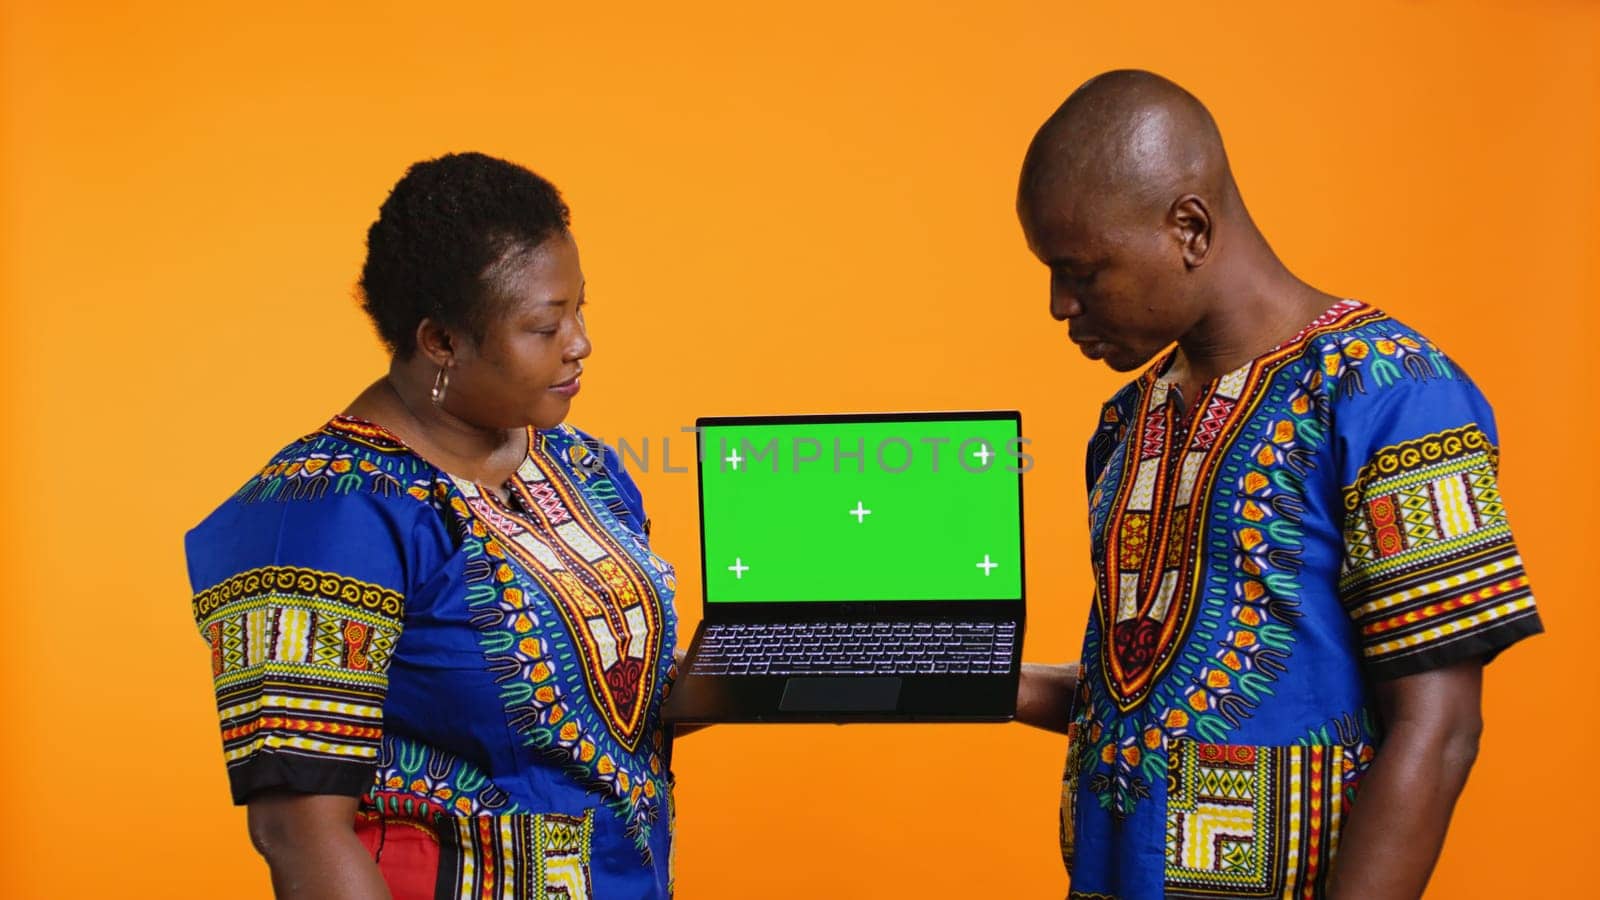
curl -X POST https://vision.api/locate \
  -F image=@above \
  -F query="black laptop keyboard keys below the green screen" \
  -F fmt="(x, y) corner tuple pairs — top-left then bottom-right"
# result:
(690, 621), (1016, 676)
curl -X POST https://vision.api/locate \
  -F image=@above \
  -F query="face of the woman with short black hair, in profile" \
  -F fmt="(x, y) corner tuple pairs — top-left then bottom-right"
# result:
(445, 234), (592, 429)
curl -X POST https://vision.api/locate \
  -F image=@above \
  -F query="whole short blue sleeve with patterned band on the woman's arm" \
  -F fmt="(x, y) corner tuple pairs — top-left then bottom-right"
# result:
(187, 492), (410, 804)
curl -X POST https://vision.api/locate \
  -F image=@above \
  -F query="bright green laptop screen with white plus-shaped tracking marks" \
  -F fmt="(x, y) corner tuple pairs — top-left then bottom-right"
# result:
(699, 416), (1030, 602)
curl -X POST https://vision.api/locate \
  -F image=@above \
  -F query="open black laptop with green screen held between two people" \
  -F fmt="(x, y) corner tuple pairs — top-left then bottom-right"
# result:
(662, 410), (1030, 722)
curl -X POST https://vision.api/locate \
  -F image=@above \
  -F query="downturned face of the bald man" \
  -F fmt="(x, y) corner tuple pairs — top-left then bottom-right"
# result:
(1018, 187), (1197, 372)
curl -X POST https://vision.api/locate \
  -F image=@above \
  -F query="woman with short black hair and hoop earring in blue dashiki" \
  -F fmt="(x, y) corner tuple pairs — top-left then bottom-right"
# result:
(187, 154), (675, 900)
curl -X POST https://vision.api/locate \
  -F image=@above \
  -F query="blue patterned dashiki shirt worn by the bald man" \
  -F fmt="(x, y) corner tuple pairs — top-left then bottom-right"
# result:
(1061, 301), (1541, 900)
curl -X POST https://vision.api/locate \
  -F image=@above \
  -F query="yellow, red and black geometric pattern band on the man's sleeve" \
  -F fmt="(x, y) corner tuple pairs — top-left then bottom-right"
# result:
(1339, 424), (1539, 677)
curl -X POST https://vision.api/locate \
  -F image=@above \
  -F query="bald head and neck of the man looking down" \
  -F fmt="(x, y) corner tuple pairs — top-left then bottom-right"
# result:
(1016, 70), (1333, 378)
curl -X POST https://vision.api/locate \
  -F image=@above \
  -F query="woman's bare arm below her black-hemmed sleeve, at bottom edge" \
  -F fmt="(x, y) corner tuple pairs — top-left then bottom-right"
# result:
(248, 793), (389, 900)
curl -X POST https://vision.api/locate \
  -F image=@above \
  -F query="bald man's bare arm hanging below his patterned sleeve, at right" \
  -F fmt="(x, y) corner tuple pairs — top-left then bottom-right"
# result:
(1328, 660), (1483, 900)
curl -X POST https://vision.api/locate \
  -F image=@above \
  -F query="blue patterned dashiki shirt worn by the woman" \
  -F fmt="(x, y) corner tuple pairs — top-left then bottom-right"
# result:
(187, 416), (677, 898)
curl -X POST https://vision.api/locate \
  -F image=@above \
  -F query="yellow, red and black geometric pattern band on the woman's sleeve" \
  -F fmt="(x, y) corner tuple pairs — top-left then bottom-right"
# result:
(194, 565), (403, 787)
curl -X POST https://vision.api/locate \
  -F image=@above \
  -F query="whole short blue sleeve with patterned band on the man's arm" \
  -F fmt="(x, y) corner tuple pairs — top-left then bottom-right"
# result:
(1334, 357), (1542, 679)
